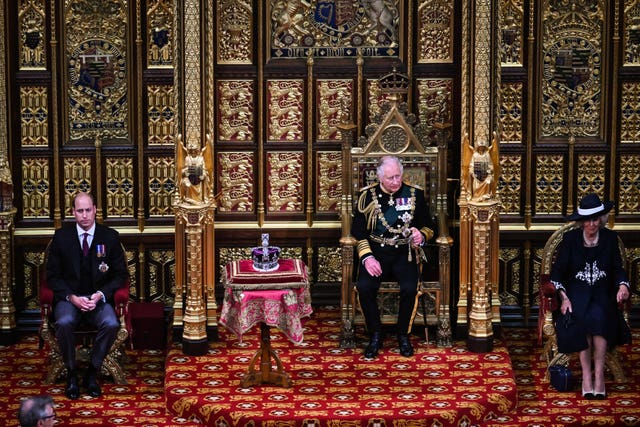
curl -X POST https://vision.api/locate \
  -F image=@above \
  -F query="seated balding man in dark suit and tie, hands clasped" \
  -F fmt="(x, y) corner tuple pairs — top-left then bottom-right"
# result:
(47, 193), (128, 399)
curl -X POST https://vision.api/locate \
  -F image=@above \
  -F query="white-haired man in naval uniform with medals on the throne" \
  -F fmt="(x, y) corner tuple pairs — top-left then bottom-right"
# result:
(351, 156), (434, 359)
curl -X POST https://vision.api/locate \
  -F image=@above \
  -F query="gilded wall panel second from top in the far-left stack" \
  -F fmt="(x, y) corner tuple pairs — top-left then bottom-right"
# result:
(20, 86), (49, 147)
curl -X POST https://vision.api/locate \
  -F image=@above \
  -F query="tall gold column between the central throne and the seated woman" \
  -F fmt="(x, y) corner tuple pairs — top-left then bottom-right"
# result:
(456, 0), (500, 352)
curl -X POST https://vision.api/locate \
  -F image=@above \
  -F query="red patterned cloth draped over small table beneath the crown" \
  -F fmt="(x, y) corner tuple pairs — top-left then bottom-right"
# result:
(220, 259), (313, 343)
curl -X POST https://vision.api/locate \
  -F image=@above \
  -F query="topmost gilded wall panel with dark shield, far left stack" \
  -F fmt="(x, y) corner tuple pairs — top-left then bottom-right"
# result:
(18, 0), (47, 69)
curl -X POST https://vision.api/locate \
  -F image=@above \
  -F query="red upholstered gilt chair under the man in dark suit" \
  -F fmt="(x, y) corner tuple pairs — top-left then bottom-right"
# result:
(40, 242), (131, 384)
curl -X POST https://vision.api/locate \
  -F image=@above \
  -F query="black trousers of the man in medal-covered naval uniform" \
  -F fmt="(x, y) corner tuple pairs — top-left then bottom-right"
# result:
(356, 243), (418, 334)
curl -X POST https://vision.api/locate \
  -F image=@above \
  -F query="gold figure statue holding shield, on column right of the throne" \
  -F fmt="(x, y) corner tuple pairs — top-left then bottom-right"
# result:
(462, 132), (500, 201)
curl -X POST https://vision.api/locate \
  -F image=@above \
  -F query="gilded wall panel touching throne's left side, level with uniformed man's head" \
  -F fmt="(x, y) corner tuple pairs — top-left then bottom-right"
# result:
(315, 151), (342, 212)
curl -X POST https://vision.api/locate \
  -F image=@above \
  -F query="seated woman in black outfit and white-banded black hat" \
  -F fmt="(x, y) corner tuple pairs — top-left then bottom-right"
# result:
(551, 194), (629, 399)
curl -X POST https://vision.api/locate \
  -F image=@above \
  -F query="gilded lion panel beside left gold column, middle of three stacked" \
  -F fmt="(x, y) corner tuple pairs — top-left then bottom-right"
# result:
(218, 80), (254, 142)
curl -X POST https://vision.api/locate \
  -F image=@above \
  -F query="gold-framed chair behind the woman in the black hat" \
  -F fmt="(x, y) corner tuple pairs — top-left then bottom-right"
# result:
(538, 221), (629, 383)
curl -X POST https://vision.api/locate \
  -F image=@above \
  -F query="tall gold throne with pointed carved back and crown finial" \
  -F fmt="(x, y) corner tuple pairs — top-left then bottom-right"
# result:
(338, 71), (453, 348)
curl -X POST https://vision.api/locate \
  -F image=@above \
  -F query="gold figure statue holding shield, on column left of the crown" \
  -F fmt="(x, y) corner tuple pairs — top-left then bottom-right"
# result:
(177, 134), (213, 204)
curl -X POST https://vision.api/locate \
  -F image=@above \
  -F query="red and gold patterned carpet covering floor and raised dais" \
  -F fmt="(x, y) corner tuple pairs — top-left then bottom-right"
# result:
(0, 309), (640, 427)
